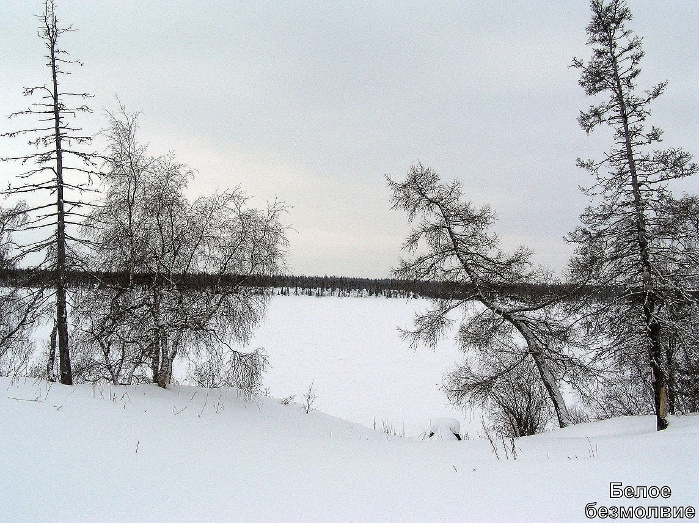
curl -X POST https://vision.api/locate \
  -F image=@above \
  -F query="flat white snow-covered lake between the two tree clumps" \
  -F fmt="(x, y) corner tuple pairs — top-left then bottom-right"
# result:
(241, 296), (480, 436)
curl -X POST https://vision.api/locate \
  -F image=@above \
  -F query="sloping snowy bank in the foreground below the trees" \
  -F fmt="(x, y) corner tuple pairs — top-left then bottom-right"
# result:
(0, 378), (699, 522)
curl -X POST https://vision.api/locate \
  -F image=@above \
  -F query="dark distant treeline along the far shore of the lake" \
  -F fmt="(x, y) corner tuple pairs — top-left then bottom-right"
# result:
(0, 269), (620, 301)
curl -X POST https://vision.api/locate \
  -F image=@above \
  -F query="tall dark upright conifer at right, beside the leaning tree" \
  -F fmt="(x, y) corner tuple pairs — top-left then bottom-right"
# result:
(569, 0), (697, 430)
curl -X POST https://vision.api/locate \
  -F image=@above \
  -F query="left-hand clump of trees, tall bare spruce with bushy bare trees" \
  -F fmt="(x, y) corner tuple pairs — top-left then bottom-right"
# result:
(0, 0), (287, 391)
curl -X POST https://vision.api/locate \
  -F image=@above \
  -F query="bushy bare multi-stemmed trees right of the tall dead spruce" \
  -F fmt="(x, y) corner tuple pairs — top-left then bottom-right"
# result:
(74, 110), (286, 387)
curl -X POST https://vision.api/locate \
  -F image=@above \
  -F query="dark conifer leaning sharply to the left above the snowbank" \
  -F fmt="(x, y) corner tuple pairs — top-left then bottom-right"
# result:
(388, 165), (584, 427)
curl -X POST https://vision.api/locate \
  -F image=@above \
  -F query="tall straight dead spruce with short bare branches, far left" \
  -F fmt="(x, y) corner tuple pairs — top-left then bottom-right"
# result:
(2, 0), (95, 384)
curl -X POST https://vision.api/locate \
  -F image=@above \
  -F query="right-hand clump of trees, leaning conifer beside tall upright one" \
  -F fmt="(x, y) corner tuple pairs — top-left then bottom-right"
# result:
(388, 0), (699, 437)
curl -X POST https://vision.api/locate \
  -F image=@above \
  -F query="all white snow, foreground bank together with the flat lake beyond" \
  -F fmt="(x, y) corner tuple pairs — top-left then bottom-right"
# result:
(0, 296), (699, 522)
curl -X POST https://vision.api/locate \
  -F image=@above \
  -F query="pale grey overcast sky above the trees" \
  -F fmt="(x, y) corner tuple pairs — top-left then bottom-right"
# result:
(0, 0), (699, 277)
